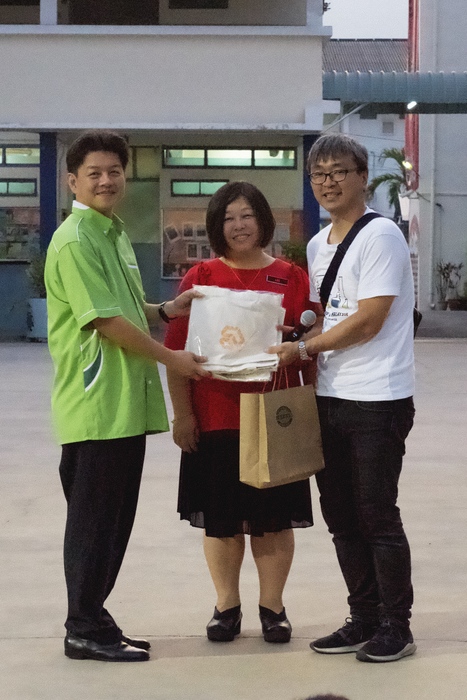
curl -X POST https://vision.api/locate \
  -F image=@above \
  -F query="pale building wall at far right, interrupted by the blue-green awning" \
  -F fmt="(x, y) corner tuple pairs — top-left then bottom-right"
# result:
(412, 0), (467, 308)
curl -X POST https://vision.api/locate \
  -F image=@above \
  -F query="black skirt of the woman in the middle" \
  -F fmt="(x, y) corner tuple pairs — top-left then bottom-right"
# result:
(178, 430), (313, 537)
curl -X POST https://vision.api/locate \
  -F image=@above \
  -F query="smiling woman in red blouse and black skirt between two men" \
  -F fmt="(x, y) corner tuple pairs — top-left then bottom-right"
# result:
(166, 182), (318, 642)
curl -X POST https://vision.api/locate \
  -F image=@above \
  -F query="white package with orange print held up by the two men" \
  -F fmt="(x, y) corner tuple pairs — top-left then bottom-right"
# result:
(185, 285), (285, 381)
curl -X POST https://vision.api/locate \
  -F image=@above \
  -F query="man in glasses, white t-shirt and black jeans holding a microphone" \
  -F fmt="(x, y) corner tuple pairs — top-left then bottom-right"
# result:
(271, 134), (416, 662)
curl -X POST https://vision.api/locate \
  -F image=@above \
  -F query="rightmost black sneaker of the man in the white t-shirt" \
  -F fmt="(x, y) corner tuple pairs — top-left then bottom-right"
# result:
(357, 620), (417, 663)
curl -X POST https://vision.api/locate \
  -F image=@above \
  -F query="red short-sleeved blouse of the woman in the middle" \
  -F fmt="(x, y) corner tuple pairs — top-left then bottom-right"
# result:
(165, 258), (321, 432)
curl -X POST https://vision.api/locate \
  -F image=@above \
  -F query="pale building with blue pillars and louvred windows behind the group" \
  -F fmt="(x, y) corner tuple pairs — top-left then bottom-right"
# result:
(0, 0), (331, 335)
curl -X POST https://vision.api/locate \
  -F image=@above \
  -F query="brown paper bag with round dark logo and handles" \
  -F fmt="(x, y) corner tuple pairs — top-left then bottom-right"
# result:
(240, 386), (324, 489)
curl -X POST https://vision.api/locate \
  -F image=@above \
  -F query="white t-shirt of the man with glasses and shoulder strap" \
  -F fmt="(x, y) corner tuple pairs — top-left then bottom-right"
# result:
(307, 208), (414, 401)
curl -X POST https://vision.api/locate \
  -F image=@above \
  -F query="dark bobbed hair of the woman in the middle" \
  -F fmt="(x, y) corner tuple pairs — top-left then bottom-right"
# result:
(206, 182), (276, 256)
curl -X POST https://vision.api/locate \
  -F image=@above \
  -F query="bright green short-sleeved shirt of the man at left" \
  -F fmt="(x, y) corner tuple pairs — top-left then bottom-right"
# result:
(45, 203), (168, 444)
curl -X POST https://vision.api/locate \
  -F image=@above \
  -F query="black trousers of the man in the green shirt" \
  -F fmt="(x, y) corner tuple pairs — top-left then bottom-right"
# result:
(60, 435), (146, 644)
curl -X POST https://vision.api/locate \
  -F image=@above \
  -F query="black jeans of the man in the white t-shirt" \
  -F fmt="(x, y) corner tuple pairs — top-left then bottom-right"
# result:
(316, 396), (415, 622)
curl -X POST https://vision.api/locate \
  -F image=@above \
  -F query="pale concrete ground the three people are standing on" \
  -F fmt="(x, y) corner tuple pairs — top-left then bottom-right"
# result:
(0, 339), (467, 700)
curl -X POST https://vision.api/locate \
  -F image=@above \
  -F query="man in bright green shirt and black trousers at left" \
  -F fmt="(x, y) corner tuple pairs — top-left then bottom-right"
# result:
(45, 131), (208, 661)
